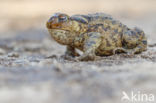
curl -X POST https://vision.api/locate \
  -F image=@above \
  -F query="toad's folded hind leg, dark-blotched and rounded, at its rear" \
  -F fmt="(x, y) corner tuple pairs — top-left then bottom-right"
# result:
(122, 28), (147, 54)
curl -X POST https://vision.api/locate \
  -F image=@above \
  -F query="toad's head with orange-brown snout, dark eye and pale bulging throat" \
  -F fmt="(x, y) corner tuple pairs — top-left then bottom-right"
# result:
(46, 13), (88, 45)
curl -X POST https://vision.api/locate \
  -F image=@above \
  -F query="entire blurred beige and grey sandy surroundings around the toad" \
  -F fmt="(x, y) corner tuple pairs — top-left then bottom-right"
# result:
(0, 0), (156, 103)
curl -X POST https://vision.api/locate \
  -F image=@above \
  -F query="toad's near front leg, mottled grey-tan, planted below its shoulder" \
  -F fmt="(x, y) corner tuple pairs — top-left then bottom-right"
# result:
(76, 32), (102, 61)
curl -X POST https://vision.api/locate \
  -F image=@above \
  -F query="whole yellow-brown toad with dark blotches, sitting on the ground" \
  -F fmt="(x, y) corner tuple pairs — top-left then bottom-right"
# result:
(46, 13), (147, 60)
